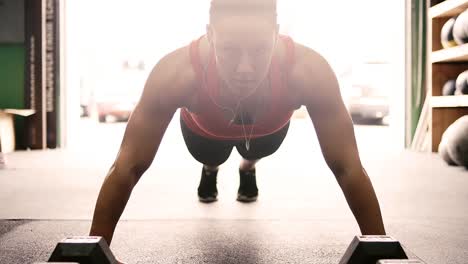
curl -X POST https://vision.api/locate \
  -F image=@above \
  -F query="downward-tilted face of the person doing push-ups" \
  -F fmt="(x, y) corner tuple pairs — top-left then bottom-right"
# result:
(207, 15), (278, 97)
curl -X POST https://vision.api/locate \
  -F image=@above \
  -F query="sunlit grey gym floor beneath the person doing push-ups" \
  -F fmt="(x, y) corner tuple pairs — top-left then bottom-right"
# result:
(0, 117), (468, 264)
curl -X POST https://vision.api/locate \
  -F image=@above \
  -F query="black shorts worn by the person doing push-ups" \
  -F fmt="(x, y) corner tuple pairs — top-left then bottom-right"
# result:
(180, 118), (289, 166)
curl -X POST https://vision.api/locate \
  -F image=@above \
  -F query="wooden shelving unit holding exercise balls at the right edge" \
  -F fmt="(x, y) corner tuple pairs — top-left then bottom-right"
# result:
(427, 0), (468, 152)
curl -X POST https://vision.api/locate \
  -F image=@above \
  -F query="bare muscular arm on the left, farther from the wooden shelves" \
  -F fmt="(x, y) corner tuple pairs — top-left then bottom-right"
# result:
(90, 49), (190, 244)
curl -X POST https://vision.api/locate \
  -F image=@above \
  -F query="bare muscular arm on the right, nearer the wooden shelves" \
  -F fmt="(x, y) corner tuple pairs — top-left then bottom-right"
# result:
(293, 47), (385, 234)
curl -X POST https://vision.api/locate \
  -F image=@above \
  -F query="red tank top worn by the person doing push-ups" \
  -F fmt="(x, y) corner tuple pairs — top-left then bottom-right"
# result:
(180, 36), (297, 140)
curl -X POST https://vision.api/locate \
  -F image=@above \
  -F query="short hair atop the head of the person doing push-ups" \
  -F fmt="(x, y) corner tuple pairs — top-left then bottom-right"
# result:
(210, 0), (277, 23)
